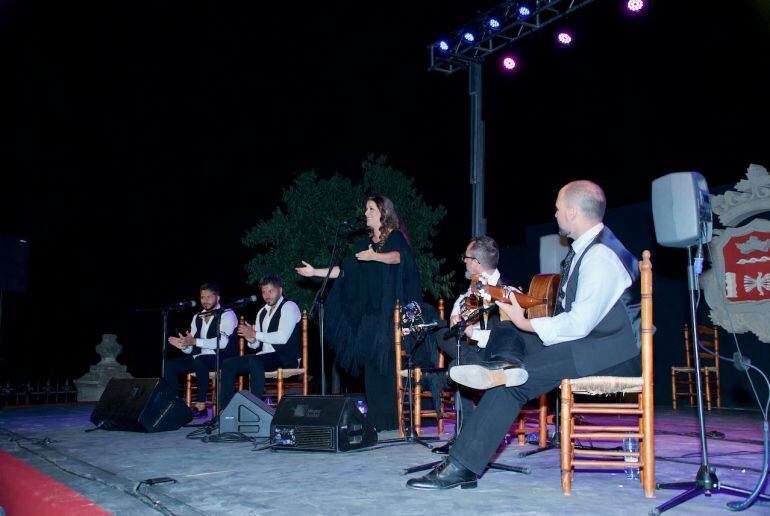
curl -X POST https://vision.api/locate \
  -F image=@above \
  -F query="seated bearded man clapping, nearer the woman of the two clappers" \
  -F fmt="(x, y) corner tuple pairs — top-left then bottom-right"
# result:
(221, 274), (302, 408)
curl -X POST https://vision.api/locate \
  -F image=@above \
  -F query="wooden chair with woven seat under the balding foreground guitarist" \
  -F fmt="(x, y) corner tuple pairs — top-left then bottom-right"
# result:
(561, 251), (655, 498)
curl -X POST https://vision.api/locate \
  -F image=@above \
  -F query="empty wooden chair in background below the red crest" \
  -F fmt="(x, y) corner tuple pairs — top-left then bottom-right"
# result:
(671, 324), (722, 410)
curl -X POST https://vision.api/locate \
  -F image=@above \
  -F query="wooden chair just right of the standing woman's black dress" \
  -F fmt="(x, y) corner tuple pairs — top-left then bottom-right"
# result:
(393, 299), (454, 437)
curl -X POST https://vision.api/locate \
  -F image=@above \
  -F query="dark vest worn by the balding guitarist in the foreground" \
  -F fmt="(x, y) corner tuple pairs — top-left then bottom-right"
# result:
(564, 226), (641, 376)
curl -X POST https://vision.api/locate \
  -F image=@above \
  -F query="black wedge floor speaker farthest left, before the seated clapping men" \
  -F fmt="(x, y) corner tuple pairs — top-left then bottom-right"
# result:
(91, 378), (193, 432)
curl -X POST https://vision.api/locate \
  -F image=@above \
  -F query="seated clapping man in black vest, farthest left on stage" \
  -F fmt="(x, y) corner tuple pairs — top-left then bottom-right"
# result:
(163, 283), (238, 413)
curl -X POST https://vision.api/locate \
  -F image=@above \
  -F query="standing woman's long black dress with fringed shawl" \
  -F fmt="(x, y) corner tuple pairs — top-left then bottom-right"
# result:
(325, 230), (422, 430)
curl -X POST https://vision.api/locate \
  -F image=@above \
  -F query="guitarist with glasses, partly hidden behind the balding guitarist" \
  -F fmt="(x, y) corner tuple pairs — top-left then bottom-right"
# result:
(432, 235), (527, 454)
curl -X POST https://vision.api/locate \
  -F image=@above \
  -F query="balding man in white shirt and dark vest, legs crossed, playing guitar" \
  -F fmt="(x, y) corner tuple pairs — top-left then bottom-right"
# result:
(407, 181), (641, 490)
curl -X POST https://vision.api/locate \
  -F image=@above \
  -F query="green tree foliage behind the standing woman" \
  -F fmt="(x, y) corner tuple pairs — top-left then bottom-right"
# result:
(243, 156), (453, 308)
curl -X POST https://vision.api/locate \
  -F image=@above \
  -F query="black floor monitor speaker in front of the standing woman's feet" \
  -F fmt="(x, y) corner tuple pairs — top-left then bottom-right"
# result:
(270, 396), (377, 452)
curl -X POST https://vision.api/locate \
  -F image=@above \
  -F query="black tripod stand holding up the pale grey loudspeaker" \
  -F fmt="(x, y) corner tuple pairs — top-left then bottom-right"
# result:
(650, 246), (770, 516)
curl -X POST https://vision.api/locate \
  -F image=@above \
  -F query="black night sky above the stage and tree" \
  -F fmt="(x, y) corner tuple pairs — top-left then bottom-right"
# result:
(0, 0), (770, 380)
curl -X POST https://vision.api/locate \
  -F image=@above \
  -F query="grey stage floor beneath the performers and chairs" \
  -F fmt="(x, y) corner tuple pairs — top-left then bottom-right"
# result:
(0, 404), (770, 516)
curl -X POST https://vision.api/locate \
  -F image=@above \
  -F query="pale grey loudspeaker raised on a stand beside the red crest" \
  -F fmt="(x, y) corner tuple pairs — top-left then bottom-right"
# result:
(652, 172), (712, 248)
